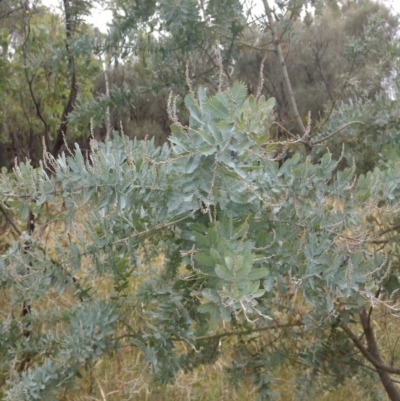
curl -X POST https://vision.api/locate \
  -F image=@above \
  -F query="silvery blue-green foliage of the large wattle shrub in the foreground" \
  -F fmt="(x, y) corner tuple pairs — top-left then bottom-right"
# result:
(0, 83), (400, 400)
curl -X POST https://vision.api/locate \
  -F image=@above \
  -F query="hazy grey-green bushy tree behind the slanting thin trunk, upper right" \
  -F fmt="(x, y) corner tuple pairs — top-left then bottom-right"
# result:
(234, 1), (398, 127)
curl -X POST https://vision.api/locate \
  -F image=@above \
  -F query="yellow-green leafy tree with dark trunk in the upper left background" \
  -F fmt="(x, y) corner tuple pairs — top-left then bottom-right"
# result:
(1, 0), (99, 166)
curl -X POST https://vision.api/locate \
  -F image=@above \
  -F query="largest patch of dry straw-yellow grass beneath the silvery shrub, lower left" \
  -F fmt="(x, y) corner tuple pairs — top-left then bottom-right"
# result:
(65, 350), (255, 401)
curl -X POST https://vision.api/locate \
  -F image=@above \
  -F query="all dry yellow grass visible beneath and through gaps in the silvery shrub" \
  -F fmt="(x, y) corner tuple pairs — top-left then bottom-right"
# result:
(0, 205), (394, 401)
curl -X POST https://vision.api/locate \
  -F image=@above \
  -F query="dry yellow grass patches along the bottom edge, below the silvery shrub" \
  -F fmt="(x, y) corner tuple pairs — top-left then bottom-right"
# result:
(63, 350), (386, 401)
